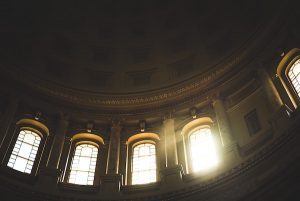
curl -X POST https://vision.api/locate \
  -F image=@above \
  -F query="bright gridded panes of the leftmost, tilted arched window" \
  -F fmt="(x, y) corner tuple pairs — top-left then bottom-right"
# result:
(7, 130), (41, 174)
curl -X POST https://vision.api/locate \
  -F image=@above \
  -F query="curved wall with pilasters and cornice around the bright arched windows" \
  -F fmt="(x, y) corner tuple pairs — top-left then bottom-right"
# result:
(0, 0), (300, 201)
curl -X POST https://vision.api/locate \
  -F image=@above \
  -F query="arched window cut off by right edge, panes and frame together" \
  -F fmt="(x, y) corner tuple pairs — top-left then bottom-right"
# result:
(277, 48), (300, 108)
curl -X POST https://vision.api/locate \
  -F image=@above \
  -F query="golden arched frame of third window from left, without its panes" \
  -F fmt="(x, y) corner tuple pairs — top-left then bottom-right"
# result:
(125, 133), (160, 185)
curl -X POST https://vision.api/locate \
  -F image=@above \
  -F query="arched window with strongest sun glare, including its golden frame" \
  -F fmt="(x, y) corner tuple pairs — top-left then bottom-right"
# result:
(182, 117), (219, 172)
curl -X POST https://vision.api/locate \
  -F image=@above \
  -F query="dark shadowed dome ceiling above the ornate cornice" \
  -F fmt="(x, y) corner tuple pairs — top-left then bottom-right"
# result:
(0, 1), (271, 94)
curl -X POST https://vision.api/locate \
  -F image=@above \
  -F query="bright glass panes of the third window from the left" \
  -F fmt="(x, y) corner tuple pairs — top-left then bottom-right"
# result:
(132, 143), (156, 184)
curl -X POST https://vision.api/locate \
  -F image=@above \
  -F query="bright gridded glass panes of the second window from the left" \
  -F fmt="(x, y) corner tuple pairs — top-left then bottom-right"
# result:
(69, 144), (98, 185)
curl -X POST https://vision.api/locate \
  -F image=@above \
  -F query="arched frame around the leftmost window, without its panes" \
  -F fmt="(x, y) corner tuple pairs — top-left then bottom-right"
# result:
(3, 118), (49, 176)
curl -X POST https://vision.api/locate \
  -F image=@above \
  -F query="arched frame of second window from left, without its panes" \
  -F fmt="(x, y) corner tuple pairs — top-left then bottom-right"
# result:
(62, 133), (106, 186)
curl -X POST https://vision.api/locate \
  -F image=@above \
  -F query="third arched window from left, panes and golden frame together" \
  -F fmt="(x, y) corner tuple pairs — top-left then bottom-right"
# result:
(126, 133), (159, 185)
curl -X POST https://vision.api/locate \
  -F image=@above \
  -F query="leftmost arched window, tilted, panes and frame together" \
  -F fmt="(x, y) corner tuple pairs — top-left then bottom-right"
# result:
(5, 119), (49, 174)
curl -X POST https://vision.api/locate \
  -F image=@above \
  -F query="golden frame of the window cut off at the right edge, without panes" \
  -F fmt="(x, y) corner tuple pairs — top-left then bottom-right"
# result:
(277, 48), (300, 109)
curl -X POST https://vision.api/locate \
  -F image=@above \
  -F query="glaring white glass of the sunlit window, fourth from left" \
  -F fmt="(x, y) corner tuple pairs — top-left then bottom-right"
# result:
(190, 128), (219, 172)
